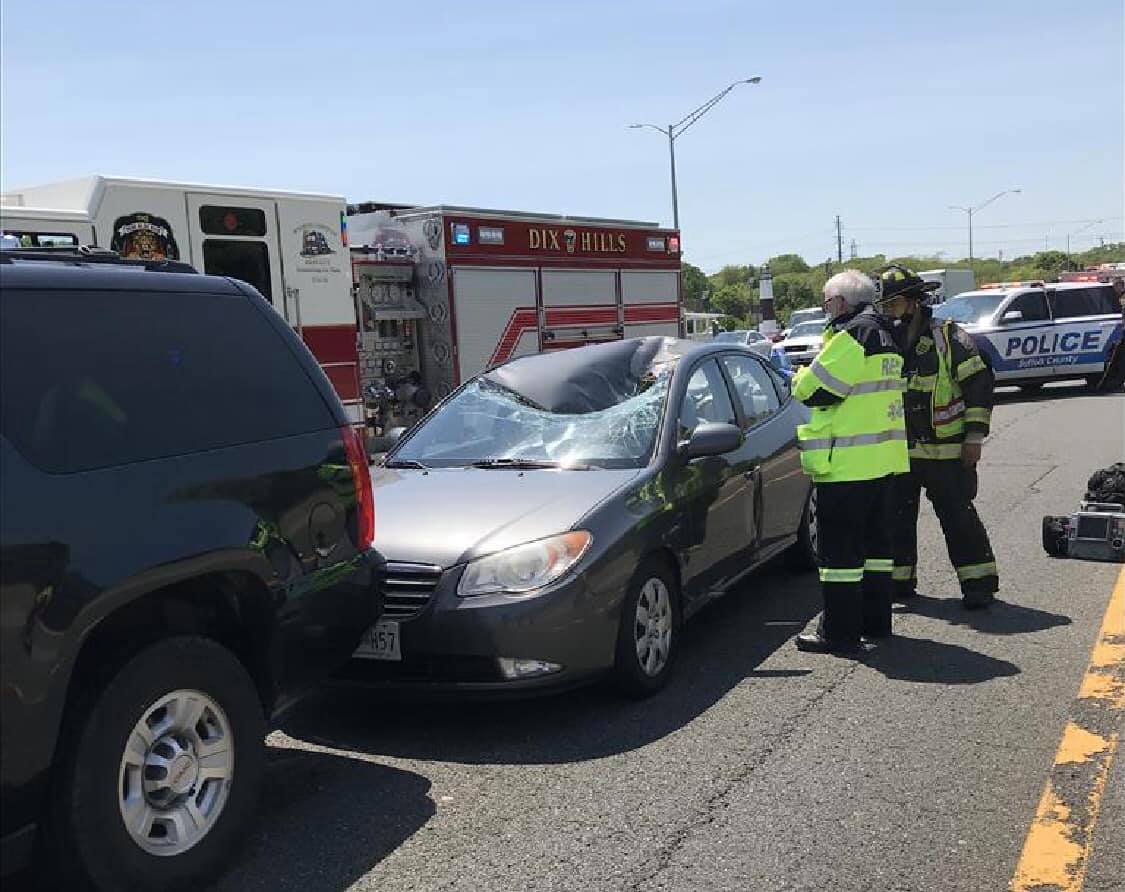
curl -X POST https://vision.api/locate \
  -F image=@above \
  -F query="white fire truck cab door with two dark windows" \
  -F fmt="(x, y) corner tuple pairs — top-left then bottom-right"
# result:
(187, 192), (283, 310)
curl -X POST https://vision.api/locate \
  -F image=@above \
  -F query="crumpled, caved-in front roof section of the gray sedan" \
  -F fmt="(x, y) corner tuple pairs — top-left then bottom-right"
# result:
(484, 337), (695, 415)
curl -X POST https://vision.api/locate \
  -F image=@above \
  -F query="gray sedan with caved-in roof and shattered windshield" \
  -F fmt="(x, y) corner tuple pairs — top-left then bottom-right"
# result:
(342, 337), (816, 694)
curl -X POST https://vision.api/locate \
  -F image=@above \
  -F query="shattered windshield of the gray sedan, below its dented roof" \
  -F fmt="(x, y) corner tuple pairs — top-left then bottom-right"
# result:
(387, 368), (672, 468)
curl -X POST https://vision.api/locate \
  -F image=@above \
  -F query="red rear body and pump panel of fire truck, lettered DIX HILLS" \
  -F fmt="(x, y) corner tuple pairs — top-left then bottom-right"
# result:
(348, 202), (681, 431)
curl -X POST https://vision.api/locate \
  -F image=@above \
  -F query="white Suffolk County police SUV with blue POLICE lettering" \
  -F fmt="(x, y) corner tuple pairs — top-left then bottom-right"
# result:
(934, 281), (1122, 390)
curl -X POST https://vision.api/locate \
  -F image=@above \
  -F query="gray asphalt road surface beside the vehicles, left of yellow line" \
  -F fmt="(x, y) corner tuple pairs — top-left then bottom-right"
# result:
(212, 386), (1125, 892)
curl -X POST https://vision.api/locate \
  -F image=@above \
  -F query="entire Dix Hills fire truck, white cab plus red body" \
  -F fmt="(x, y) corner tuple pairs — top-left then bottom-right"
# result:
(0, 177), (680, 433)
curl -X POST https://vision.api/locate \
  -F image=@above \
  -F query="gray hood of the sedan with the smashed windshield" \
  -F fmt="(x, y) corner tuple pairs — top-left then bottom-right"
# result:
(372, 468), (641, 567)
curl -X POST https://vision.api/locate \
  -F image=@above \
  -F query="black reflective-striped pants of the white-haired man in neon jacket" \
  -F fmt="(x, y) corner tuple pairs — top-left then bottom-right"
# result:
(817, 477), (894, 645)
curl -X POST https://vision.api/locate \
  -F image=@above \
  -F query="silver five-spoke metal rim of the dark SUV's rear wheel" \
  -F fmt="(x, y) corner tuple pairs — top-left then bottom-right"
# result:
(117, 691), (234, 856)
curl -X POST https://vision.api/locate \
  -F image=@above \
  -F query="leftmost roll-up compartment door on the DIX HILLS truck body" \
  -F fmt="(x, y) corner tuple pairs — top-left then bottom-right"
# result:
(452, 267), (539, 381)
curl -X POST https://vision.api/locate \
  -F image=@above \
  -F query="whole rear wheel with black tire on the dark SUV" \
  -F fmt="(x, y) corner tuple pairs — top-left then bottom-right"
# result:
(48, 637), (266, 892)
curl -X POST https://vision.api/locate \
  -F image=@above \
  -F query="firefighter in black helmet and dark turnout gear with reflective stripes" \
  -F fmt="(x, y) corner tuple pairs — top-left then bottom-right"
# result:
(881, 265), (999, 610)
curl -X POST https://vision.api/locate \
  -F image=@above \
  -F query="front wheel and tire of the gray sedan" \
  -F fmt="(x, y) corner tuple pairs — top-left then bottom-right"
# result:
(613, 558), (682, 699)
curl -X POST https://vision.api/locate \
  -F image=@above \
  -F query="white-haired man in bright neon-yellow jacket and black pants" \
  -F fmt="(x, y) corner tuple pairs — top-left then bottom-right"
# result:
(793, 270), (909, 655)
